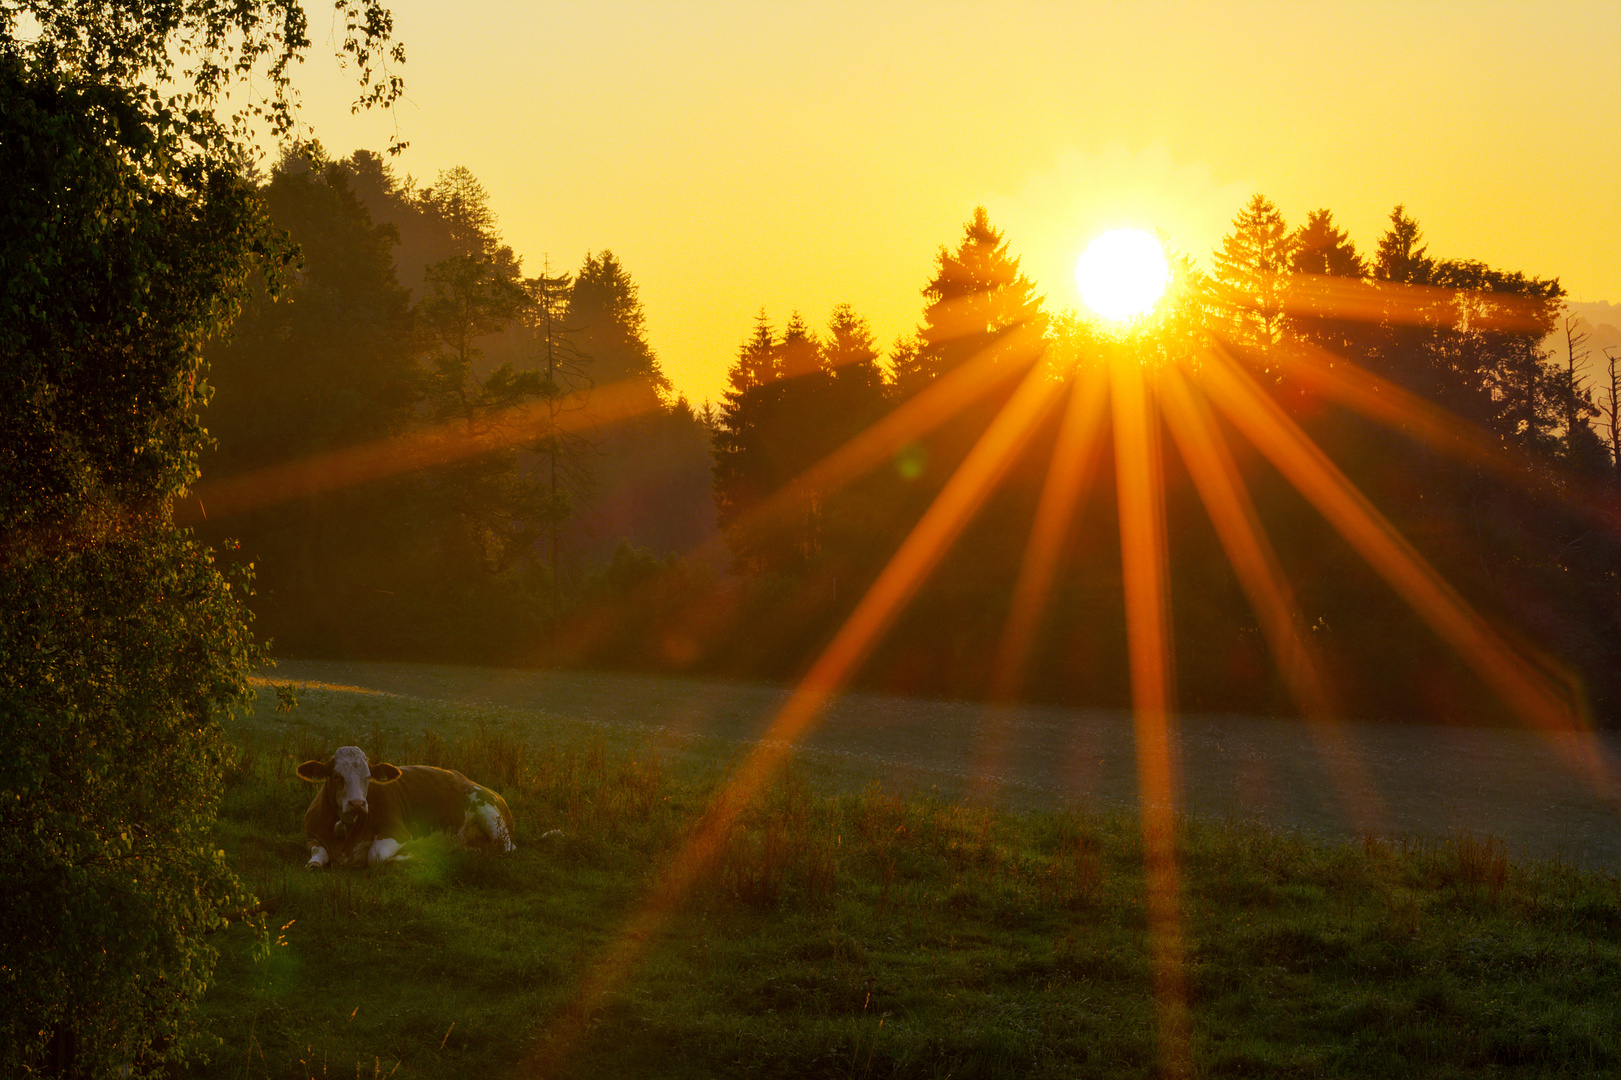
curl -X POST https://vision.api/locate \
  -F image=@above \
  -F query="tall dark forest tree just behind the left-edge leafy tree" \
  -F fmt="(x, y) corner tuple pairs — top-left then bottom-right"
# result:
(198, 154), (425, 650)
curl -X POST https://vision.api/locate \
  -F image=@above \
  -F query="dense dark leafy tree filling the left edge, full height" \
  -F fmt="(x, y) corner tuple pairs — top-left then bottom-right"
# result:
(0, 57), (279, 1075)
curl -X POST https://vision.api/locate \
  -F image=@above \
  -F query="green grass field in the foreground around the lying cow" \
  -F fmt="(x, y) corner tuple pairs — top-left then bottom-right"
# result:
(198, 677), (1621, 1078)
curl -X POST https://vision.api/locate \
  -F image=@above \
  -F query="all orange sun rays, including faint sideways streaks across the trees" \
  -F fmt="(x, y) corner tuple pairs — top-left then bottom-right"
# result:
(186, 246), (1618, 1075)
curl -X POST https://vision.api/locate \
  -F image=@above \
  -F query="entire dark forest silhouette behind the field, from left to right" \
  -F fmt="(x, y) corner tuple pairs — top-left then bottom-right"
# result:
(204, 162), (1621, 722)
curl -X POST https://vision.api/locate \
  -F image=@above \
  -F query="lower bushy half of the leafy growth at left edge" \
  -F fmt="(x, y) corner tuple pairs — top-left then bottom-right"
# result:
(0, 522), (258, 1075)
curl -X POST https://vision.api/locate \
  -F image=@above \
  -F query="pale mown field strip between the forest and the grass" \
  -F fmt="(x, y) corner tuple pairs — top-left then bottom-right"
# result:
(267, 660), (1621, 869)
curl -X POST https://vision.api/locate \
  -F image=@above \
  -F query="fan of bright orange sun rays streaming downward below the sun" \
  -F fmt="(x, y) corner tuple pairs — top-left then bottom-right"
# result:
(528, 269), (1613, 1075)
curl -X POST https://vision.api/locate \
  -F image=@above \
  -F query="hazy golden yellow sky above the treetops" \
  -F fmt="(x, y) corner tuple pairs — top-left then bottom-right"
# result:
(291, 0), (1621, 401)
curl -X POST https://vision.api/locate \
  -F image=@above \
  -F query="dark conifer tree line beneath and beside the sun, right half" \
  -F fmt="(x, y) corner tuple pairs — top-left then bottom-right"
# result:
(695, 196), (1621, 723)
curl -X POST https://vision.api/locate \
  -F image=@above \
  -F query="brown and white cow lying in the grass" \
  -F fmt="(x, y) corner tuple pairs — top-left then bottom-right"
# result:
(298, 746), (515, 869)
